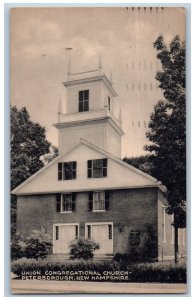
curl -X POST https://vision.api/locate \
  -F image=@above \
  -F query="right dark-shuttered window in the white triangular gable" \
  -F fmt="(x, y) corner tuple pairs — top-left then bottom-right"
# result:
(88, 158), (107, 178)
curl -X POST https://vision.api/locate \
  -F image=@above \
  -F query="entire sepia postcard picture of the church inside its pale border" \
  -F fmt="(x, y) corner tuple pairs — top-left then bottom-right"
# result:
(9, 4), (188, 295)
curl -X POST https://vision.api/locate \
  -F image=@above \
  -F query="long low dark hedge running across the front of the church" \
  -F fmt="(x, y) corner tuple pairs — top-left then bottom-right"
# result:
(11, 258), (186, 283)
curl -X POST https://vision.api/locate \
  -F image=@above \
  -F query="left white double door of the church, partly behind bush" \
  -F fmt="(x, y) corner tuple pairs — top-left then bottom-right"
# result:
(53, 224), (78, 254)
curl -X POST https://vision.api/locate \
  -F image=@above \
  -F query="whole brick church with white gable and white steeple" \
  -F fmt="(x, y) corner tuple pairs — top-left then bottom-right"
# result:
(12, 65), (186, 260)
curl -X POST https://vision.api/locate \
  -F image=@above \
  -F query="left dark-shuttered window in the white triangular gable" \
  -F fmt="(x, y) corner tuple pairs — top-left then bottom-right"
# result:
(58, 161), (77, 180)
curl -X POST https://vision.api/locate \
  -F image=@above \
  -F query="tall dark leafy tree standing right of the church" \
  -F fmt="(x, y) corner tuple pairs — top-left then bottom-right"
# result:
(145, 36), (186, 261)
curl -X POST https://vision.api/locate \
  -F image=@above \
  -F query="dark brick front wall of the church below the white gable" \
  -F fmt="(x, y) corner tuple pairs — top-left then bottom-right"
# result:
(17, 188), (158, 256)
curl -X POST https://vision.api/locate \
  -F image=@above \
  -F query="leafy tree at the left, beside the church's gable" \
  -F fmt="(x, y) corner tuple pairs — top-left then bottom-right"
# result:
(11, 106), (56, 234)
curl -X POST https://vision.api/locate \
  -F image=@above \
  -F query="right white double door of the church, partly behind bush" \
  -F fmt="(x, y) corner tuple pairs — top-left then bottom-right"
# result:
(88, 223), (113, 254)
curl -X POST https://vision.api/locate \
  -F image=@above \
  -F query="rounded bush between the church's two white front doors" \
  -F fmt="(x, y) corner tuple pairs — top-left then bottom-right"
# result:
(69, 238), (99, 260)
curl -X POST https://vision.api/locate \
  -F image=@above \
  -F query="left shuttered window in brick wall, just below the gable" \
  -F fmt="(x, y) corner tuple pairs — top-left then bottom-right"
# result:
(56, 193), (76, 212)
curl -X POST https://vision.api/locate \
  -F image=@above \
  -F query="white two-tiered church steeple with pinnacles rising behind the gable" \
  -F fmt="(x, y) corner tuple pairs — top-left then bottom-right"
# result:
(54, 63), (123, 157)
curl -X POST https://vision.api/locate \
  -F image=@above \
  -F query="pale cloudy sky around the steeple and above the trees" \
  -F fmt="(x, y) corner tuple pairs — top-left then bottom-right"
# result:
(10, 7), (185, 157)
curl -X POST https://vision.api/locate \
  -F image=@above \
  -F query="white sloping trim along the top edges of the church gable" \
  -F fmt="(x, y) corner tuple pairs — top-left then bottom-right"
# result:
(12, 139), (161, 195)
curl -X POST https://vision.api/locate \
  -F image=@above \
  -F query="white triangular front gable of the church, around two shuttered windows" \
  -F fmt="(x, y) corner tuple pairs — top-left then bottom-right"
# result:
(12, 139), (165, 195)
